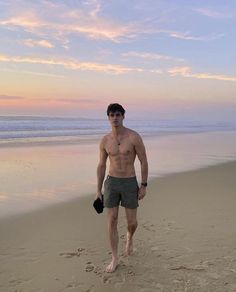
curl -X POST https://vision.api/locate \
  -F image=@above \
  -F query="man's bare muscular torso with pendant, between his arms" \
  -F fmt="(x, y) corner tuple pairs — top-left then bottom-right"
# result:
(104, 128), (137, 177)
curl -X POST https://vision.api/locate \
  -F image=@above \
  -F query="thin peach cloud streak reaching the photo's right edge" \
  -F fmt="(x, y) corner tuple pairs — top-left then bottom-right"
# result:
(168, 67), (236, 82)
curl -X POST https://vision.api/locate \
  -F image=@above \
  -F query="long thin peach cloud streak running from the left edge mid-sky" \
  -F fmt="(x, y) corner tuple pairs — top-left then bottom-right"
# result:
(0, 55), (144, 74)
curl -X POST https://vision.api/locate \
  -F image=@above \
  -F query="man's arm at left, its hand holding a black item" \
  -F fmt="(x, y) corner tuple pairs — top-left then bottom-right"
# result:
(96, 138), (108, 199)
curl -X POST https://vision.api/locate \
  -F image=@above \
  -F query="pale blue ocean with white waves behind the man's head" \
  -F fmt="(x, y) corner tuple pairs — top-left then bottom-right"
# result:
(0, 116), (236, 147)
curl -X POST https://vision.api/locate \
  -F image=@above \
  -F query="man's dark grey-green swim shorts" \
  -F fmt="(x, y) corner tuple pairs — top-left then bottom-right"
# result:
(104, 175), (139, 209)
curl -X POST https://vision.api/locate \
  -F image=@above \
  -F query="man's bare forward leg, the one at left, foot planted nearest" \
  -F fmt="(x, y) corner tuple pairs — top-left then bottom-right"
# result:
(106, 207), (119, 273)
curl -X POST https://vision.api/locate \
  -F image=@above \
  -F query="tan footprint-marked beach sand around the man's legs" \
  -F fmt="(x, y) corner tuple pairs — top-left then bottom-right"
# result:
(0, 162), (236, 292)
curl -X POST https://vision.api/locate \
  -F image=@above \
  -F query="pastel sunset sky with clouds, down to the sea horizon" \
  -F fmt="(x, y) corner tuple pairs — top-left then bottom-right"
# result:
(0, 0), (236, 121)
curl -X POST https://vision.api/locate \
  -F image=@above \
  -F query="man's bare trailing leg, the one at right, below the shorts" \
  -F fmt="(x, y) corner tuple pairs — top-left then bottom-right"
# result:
(125, 208), (138, 255)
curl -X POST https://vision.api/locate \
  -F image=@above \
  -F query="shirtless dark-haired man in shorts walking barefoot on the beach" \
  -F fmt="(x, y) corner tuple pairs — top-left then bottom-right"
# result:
(96, 103), (148, 273)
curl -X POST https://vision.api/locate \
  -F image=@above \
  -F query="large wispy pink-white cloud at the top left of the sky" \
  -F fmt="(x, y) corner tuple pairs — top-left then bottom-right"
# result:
(0, 1), (137, 42)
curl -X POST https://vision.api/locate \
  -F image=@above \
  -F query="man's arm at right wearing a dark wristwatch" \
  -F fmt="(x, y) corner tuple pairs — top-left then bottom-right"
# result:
(134, 134), (148, 200)
